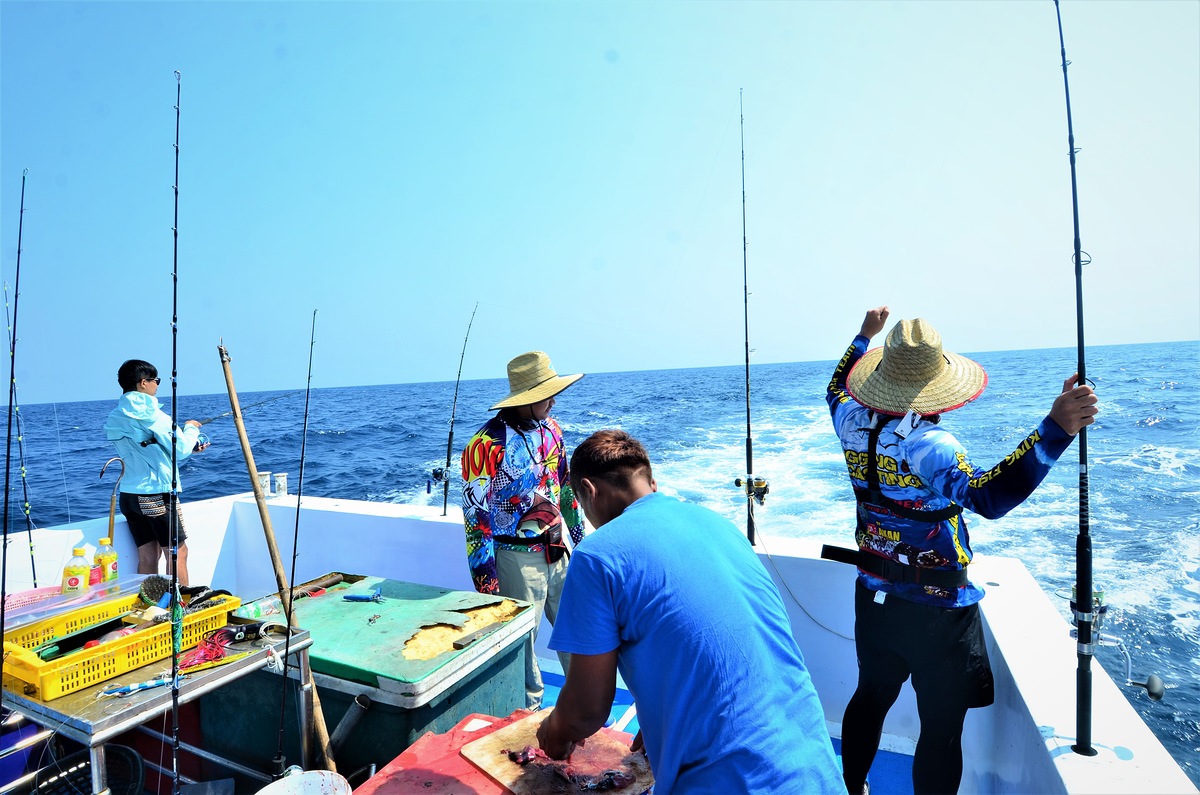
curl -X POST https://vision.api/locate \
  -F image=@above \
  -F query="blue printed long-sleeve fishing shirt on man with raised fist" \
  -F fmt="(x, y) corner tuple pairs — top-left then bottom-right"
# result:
(826, 335), (1074, 608)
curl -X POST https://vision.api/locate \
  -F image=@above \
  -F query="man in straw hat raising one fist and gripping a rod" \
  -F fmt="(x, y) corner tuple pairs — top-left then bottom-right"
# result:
(822, 306), (1097, 795)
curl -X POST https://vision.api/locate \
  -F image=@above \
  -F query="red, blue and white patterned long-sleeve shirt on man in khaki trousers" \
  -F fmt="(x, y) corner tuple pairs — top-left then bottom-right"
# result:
(462, 414), (583, 593)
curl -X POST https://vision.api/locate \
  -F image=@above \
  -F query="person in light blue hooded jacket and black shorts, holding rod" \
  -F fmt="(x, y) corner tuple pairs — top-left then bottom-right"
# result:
(104, 359), (208, 585)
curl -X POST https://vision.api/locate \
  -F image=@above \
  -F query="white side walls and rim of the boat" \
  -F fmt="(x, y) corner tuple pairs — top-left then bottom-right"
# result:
(8, 495), (1196, 795)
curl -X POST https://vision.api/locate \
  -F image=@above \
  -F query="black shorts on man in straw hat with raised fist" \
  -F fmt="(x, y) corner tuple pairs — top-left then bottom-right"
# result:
(854, 582), (995, 709)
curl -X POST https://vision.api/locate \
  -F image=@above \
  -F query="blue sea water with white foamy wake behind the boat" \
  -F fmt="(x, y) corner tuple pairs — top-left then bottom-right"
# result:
(10, 340), (1200, 784)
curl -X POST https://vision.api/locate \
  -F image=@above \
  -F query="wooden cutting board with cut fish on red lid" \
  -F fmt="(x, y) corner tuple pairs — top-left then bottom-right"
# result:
(461, 709), (654, 795)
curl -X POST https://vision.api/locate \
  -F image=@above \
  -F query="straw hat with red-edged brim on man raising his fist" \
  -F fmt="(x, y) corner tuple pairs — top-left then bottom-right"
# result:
(846, 318), (988, 417)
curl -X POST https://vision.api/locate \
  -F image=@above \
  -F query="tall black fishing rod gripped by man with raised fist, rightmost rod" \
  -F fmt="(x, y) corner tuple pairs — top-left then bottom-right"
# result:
(1054, 0), (1098, 757)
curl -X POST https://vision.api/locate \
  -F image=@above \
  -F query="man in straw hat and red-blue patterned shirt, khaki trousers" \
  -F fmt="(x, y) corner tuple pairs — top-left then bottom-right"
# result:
(462, 351), (583, 709)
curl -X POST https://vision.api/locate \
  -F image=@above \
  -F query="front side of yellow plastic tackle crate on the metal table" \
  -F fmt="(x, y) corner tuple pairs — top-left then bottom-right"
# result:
(4, 596), (241, 701)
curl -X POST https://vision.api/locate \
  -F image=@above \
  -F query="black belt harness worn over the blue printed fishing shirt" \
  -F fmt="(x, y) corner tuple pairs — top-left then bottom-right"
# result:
(821, 414), (967, 588)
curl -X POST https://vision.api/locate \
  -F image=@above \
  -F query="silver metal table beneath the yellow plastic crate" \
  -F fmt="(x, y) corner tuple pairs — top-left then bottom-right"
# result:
(2, 628), (312, 795)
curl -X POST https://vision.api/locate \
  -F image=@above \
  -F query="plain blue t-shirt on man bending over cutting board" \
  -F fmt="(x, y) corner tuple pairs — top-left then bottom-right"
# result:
(550, 492), (846, 795)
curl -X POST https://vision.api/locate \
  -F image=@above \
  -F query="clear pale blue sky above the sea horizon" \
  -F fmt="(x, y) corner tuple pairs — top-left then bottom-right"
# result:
(0, 0), (1200, 404)
